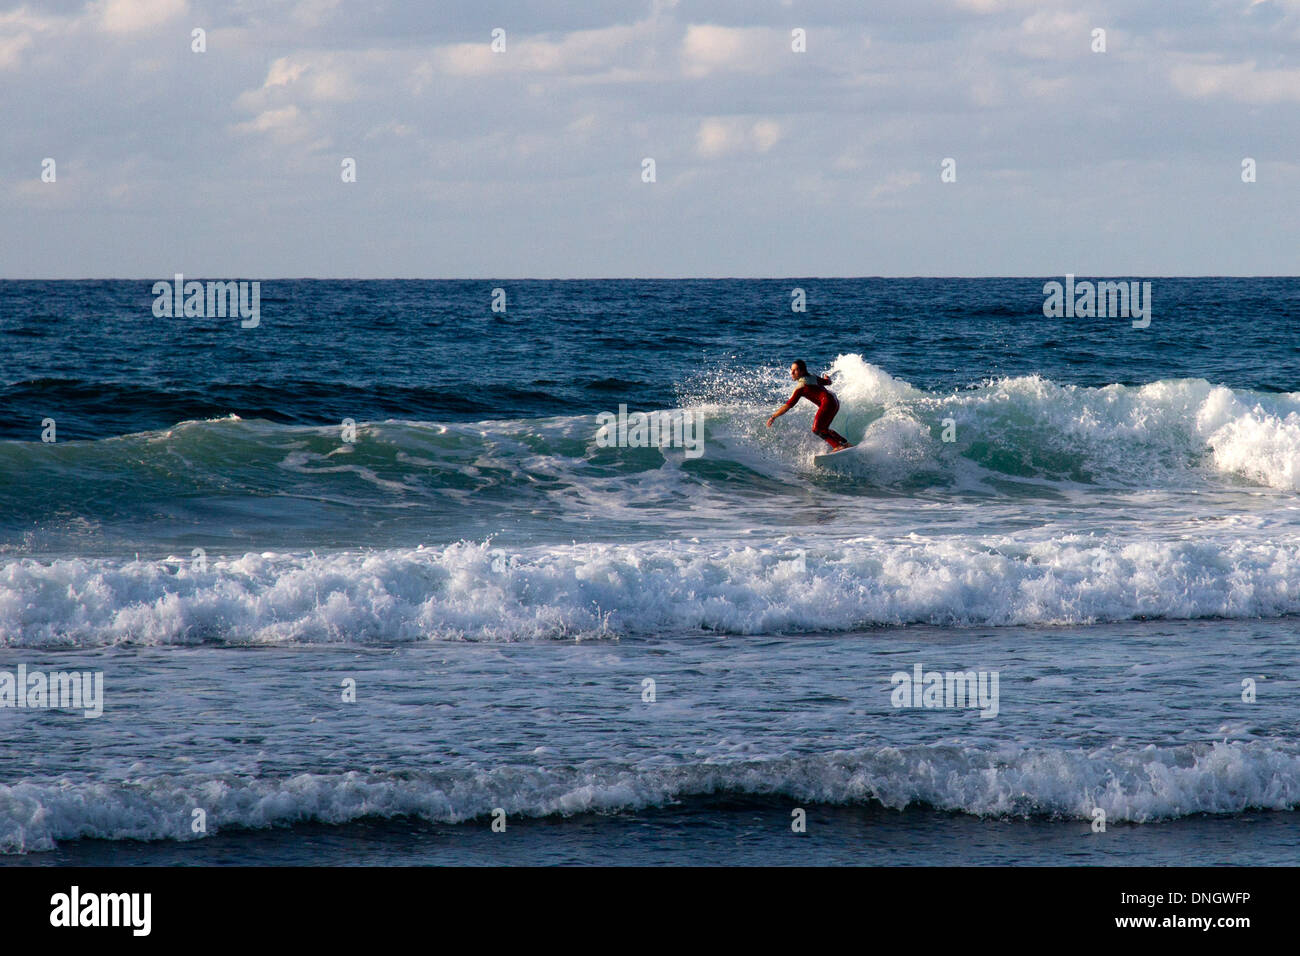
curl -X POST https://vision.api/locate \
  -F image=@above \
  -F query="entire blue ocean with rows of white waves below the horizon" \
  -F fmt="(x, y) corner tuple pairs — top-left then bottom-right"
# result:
(0, 276), (1300, 865)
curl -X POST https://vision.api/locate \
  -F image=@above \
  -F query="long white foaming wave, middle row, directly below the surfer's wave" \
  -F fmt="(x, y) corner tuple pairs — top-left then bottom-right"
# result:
(0, 535), (1300, 646)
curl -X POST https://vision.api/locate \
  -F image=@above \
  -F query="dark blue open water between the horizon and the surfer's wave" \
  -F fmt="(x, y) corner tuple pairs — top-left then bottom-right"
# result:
(0, 276), (1300, 441)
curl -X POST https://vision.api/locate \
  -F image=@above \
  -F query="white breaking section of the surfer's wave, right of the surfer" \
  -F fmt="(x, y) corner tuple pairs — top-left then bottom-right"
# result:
(806, 355), (1300, 490)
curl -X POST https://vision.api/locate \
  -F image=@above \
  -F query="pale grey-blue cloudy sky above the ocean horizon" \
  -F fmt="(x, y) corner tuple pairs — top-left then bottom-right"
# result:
(0, 0), (1300, 278)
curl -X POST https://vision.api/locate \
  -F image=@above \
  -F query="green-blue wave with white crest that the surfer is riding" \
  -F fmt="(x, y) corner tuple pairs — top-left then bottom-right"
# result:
(0, 355), (1300, 527)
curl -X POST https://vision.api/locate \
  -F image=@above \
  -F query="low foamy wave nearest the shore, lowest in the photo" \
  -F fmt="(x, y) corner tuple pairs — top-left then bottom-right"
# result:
(0, 741), (1300, 853)
